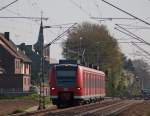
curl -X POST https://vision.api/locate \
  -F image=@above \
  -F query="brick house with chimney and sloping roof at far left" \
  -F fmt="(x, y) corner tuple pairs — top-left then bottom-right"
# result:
(0, 32), (31, 93)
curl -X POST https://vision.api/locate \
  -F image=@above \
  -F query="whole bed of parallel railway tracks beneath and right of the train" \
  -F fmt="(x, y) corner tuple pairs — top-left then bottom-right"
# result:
(13, 100), (142, 116)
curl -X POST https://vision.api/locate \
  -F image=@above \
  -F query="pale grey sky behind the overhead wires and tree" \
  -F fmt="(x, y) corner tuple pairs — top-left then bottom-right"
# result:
(0, 0), (150, 62)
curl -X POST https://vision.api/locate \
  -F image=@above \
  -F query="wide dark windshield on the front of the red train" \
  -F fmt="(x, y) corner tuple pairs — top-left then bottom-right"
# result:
(56, 66), (77, 87)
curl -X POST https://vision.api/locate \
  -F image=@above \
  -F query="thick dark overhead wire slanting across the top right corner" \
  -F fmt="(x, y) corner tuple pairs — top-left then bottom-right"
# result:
(102, 0), (150, 26)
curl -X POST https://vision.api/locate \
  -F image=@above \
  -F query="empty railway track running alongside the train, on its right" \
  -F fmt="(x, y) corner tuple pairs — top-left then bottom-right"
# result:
(45, 100), (141, 116)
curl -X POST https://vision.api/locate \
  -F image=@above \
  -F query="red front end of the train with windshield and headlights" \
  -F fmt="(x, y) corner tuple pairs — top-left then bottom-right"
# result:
(50, 64), (78, 107)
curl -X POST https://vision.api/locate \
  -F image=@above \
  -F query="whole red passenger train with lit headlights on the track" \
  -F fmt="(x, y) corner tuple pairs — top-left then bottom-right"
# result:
(49, 61), (105, 107)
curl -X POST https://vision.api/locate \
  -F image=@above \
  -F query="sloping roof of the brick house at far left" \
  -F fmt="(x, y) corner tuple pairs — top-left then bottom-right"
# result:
(0, 33), (32, 62)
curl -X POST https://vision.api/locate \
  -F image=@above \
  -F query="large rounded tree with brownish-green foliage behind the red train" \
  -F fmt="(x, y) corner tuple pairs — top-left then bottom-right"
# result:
(63, 22), (123, 96)
